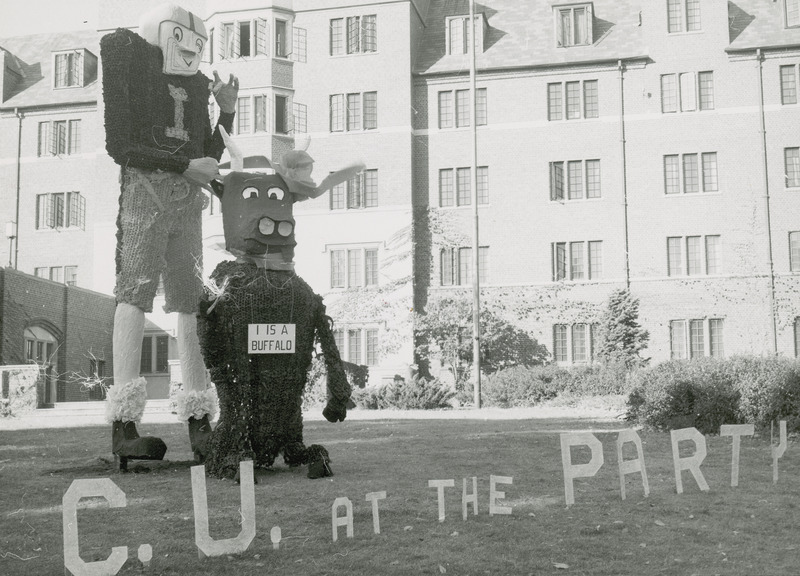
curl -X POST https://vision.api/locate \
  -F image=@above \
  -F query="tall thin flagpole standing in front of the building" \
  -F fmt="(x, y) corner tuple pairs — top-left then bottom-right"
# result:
(468, 0), (481, 408)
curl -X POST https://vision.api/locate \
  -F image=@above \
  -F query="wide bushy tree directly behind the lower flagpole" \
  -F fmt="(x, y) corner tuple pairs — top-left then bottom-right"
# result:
(414, 295), (548, 390)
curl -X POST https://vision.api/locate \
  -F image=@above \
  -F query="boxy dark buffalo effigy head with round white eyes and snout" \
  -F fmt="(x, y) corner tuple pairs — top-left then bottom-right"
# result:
(221, 171), (297, 270)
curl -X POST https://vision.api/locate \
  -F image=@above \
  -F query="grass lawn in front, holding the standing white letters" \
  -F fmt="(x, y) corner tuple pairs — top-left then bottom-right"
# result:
(0, 419), (800, 576)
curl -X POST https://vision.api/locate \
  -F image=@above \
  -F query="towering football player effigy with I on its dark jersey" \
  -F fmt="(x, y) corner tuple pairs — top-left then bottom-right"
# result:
(100, 4), (238, 470)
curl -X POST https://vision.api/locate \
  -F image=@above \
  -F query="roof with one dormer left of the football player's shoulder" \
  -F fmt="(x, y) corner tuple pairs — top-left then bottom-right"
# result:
(0, 30), (100, 109)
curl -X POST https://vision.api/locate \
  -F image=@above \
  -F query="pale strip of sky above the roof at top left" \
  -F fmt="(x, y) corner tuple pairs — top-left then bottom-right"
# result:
(0, 0), (102, 38)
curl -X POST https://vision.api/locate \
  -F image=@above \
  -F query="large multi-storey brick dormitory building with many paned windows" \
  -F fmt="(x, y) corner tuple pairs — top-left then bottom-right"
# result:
(0, 0), (800, 399)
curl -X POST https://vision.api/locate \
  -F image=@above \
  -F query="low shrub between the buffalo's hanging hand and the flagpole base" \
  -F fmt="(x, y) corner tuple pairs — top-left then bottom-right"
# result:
(353, 376), (455, 410)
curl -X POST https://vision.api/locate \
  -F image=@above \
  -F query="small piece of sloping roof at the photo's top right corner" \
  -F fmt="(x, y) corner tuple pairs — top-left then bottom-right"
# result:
(726, 0), (800, 52)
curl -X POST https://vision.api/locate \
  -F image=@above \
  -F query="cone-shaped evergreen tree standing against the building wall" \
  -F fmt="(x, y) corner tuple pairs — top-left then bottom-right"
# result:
(597, 289), (650, 369)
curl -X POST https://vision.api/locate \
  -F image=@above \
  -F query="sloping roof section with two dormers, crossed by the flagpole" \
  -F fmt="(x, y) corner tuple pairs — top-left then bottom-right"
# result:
(414, 0), (647, 74)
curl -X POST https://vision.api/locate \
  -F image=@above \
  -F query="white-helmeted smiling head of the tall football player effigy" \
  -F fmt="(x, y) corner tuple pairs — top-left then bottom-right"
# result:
(139, 4), (208, 76)
